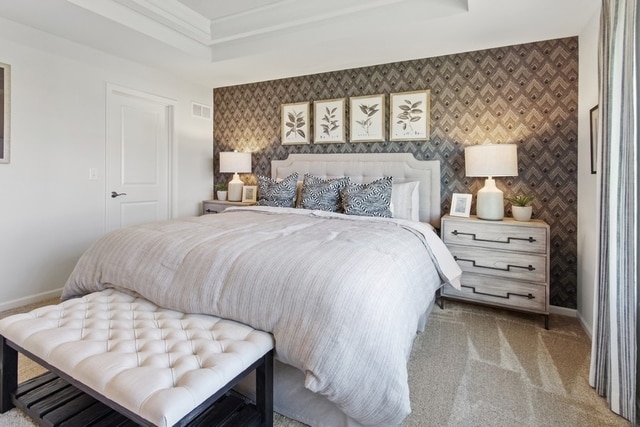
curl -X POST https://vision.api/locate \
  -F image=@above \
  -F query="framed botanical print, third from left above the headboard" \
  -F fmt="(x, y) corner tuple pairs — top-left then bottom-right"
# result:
(349, 94), (385, 142)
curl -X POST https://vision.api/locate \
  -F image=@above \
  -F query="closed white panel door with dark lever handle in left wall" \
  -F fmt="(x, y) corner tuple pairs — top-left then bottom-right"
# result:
(106, 86), (173, 231)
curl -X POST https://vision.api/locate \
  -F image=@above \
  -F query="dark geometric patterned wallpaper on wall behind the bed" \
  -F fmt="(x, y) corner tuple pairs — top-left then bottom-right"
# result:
(214, 37), (578, 308)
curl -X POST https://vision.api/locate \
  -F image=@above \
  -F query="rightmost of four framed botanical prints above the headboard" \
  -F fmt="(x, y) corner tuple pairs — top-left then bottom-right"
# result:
(389, 90), (431, 141)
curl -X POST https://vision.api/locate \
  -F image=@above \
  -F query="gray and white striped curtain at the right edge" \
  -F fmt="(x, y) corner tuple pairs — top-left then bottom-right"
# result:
(589, 0), (640, 425)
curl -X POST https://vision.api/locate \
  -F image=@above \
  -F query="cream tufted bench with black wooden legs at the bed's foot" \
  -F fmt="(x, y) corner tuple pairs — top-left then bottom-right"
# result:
(0, 289), (273, 426)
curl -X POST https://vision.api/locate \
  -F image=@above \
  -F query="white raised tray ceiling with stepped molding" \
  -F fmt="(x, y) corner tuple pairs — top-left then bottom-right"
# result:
(0, 0), (599, 87)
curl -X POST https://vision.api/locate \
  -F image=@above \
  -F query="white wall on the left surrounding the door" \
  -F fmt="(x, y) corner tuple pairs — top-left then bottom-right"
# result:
(0, 19), (213, 311)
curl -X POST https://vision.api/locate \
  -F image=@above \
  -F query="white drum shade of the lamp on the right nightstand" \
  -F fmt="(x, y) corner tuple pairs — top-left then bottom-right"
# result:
(464, 144), (518, 177)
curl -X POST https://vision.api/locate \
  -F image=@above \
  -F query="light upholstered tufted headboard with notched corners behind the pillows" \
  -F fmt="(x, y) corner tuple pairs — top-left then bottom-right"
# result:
(271, 153), (441, 228)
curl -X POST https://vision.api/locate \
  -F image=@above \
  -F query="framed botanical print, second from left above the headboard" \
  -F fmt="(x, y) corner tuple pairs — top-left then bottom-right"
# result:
(313, 98), (346, 144)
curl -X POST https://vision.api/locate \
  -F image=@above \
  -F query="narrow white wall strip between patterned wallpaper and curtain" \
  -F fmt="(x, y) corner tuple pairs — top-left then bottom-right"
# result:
(578, 10), (600, 335)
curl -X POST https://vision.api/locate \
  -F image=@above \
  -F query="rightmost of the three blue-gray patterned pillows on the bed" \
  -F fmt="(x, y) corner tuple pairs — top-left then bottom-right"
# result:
(340, 176), (393, 218)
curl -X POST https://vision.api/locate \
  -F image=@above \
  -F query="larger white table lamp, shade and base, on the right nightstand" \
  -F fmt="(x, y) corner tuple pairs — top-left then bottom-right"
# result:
(464, 144), (518, 221)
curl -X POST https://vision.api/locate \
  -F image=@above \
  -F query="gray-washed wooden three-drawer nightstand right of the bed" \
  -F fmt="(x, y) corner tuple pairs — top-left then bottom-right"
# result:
(441, 215), (550, 329)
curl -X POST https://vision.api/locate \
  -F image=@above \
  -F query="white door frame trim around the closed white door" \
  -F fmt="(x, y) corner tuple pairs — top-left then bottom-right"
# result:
(103, 83), (178, 232)
